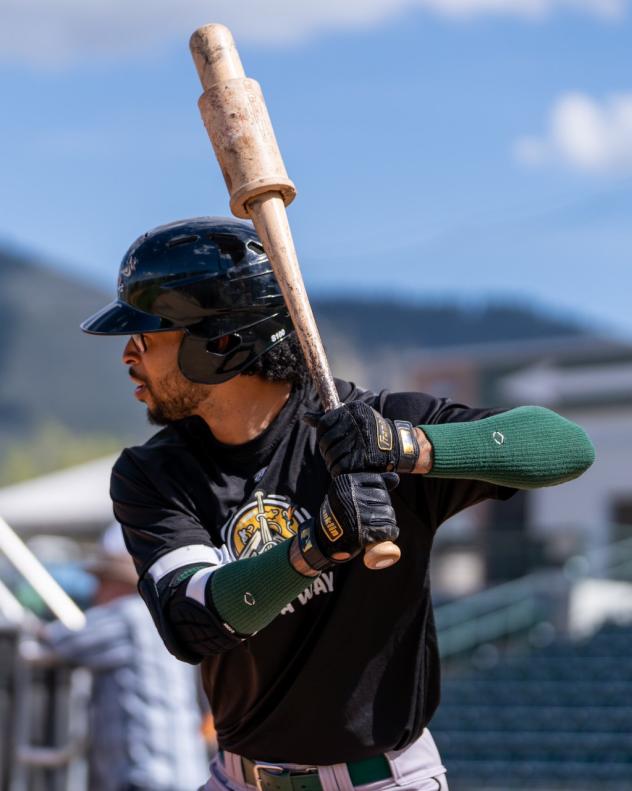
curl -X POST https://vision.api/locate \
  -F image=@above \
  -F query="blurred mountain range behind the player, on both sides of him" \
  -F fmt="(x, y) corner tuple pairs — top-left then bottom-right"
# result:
(0, 244), (585, 443)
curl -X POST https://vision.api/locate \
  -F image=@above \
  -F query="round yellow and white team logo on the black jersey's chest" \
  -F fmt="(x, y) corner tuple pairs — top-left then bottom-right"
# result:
(222, 490), (309, 558)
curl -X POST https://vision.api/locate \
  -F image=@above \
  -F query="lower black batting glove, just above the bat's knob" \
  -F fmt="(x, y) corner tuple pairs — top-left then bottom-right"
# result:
(298, 472), (399, 571)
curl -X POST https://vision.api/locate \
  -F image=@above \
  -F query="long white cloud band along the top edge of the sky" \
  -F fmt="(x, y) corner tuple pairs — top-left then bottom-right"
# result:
(0, 0), (629, 67)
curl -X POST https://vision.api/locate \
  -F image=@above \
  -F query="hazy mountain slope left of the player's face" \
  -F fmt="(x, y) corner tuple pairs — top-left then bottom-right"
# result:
(0, 251), (139, 441)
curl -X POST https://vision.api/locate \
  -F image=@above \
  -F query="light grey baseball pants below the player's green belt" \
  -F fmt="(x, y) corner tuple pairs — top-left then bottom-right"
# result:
(200, 729), (448, 791)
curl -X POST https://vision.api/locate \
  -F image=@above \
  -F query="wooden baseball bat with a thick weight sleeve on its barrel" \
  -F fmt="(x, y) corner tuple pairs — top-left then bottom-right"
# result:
(190, 25), (400, 569)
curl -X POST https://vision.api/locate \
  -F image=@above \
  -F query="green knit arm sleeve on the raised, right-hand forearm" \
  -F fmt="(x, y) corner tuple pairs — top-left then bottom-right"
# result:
(419, 406), (595, 489)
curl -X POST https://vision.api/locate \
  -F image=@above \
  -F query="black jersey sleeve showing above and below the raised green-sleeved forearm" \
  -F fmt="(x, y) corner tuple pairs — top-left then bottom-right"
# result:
(373, 393), (516, 530)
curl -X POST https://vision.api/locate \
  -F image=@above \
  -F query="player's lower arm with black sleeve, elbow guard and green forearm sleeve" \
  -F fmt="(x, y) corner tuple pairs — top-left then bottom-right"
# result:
(111, 449), (313, 664)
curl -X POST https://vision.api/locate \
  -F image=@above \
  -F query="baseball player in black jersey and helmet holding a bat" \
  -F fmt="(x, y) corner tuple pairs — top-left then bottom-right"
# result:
(82, 218), (594, 791)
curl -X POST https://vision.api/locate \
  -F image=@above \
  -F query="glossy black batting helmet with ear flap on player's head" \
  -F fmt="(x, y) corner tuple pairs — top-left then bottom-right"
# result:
(81, 217), (293, 384)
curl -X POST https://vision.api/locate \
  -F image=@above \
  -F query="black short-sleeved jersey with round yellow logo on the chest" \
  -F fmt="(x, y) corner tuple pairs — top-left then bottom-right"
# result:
(111, 382), (513, 765)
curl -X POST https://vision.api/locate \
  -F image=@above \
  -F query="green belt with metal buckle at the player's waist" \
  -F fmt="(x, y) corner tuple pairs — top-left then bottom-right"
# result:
(233, 755), (393, 791)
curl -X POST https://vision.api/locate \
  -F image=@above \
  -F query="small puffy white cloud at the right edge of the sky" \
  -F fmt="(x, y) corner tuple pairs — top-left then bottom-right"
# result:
(514, 93), (632, 173)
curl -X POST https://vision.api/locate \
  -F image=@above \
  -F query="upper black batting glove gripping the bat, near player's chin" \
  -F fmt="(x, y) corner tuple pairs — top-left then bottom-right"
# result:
(303, 401), (419, 476)
